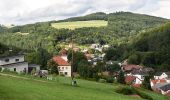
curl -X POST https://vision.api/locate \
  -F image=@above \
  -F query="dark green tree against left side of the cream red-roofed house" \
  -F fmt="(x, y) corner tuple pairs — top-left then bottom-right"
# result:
(47, 60), (58, 75)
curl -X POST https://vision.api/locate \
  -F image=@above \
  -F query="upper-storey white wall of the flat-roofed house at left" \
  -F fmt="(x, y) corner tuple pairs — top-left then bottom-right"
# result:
(0, 55), (24, 65)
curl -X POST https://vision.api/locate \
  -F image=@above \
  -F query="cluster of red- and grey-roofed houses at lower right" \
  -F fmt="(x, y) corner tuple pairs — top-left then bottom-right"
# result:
(121, 60), (170, 96)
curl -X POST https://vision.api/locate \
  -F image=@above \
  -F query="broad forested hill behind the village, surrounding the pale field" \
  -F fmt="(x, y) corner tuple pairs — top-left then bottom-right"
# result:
(0, 12), (169, 52)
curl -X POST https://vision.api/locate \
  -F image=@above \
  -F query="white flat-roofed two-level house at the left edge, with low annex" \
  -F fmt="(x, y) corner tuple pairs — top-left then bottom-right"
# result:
(0, 55), (40, 73)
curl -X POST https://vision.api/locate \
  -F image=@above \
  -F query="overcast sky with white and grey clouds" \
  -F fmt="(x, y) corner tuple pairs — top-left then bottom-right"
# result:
(0, 0), (170, 24)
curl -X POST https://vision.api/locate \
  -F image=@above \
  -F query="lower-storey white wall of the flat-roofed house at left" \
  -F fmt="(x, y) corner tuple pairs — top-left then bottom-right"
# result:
(2, 62), (28, 73)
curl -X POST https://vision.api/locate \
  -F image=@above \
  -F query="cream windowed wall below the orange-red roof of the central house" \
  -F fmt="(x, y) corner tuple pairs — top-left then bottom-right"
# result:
(58, 66), (71, 77)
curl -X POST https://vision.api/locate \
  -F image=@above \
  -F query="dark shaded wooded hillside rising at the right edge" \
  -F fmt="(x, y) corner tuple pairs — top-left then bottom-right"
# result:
(129, 23), (170, 71)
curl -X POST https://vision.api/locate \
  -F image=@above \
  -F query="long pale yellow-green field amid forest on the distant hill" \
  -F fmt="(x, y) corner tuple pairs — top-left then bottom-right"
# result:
(51, 20), (108, 30)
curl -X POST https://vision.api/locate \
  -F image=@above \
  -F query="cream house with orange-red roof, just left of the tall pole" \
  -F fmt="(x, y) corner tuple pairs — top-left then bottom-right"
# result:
(53, 56), (71, 77)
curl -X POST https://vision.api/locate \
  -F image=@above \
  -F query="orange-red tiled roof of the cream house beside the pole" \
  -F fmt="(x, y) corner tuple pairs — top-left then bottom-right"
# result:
(53, 56), (70, 66)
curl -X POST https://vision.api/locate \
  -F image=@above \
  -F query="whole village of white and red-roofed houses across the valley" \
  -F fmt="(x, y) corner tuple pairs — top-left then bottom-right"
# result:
(0, 44), (170, 96)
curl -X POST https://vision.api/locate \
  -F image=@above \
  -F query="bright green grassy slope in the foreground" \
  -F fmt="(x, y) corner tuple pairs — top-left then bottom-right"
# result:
(0, 75), (168, 100)
